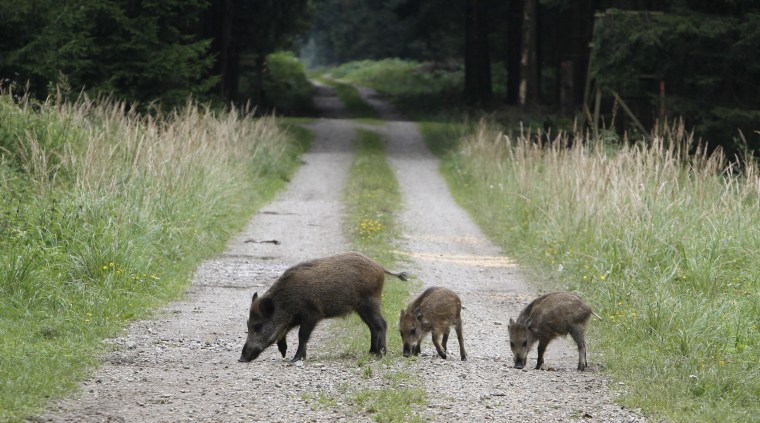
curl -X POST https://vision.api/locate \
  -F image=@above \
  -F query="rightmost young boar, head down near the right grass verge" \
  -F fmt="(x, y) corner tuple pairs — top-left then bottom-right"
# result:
(508, 292), (601, 370)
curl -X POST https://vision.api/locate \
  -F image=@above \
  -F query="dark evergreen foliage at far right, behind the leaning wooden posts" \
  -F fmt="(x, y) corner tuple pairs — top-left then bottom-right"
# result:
(591, 1), (760, 155)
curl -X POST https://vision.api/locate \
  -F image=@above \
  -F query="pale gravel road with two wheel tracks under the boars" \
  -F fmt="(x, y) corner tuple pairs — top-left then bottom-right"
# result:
(29, 87), (644, 422)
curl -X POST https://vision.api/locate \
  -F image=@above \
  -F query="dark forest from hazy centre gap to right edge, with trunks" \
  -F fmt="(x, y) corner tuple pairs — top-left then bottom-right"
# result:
(302, 0), (760, 157)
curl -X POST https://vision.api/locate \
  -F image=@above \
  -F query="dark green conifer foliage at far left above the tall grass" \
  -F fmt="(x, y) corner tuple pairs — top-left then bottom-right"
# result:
(0, 0), (215, 102)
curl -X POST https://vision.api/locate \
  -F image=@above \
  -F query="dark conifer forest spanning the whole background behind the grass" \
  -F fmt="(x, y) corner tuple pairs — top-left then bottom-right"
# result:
(0, 0), (760, 157)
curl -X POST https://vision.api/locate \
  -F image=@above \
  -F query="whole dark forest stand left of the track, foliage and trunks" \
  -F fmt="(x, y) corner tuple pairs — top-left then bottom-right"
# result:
(0, 0), (312, 104)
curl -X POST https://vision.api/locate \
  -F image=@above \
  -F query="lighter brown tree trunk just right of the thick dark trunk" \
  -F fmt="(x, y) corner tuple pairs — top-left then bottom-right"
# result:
(519, 0), (538, 108)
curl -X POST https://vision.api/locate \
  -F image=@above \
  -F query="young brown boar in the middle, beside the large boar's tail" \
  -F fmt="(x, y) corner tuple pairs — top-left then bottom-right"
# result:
(398, 286), (467, 360)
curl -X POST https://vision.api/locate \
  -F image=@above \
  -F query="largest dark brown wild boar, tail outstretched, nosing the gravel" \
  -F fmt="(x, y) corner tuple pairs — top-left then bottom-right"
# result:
(238, 252), (406, 362)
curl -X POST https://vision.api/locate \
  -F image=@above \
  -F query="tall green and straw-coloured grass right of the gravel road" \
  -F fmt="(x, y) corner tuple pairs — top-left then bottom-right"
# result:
(428, 121), (760, 421)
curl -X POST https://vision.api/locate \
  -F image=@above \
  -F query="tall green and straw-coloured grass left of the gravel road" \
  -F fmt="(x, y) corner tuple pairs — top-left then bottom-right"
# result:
(0, 95), (301, 420)
